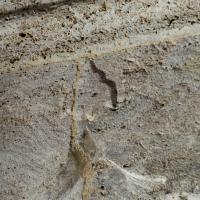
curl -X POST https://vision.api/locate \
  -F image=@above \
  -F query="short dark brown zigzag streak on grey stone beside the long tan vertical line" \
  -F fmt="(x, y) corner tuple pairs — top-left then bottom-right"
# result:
(90, 60), (118, 108)
